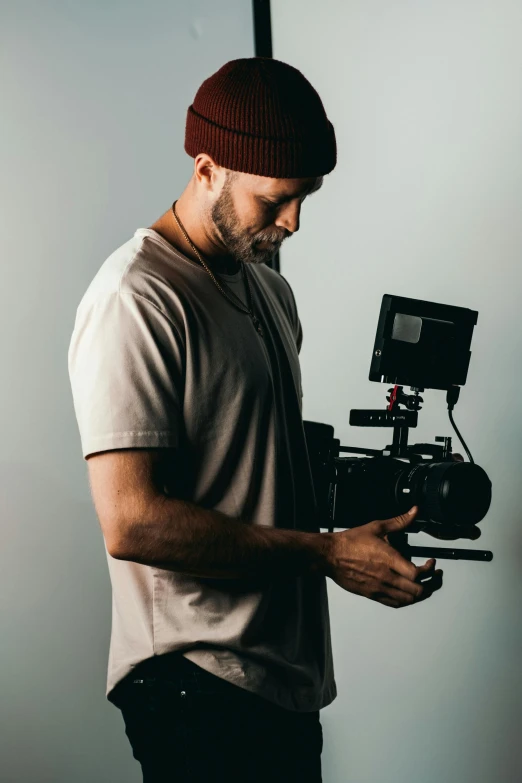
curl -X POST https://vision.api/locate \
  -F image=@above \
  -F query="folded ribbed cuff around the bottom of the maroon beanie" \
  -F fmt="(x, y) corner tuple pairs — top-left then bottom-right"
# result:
(185, 106), (337, 179)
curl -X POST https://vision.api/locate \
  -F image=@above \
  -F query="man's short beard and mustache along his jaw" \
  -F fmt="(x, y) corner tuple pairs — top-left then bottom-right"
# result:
(210, 180), (289, 264)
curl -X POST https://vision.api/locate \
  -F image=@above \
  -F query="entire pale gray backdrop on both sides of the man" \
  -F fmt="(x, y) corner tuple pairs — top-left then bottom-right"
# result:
(0, 0), (522, 783)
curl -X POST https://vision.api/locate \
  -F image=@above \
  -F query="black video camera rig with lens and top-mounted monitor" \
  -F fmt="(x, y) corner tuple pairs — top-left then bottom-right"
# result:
(304, 294), (493, 561)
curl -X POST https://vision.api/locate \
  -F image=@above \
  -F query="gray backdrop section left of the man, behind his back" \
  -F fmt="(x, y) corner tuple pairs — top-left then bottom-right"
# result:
(0, 0), (254, 783)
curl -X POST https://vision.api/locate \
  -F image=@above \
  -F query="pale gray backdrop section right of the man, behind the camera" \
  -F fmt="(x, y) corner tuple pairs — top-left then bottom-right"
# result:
(272, 0), (522, 783)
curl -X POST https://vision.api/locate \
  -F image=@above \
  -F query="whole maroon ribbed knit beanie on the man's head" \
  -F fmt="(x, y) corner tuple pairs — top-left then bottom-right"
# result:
(185, 57), (337, 178)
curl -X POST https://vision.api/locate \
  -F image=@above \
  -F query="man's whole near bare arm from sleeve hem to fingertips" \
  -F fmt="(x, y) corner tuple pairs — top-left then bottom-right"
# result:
(88, 448), (436, 608)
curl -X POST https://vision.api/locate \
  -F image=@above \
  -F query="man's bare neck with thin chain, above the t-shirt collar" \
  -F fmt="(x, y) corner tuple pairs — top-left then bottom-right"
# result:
(149, 196), (240, 275)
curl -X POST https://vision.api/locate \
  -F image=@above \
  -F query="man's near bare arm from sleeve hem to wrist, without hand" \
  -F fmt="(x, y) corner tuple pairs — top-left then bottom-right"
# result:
(87, 448), (330, 580)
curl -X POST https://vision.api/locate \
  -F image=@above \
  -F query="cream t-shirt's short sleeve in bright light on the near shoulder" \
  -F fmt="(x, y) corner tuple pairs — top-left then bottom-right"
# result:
(68, 291), (185, 459)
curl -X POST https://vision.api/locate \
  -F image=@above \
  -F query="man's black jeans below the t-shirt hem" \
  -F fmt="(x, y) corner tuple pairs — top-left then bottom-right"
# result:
(110, 655), (323, 783)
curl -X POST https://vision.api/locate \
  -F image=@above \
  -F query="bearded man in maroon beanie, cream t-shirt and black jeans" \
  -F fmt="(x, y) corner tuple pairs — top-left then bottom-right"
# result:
(69, 58), (441, 783)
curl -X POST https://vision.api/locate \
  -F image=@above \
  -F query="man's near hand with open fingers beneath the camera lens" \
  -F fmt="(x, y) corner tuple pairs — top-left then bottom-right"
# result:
(326, 506), (443, 609)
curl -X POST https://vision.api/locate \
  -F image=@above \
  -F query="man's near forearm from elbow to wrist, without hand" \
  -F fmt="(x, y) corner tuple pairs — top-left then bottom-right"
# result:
(113, 495), (331, 579)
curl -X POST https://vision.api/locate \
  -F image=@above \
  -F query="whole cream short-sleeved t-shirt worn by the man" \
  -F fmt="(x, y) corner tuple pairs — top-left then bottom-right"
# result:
(68, 228), (337, 712)
